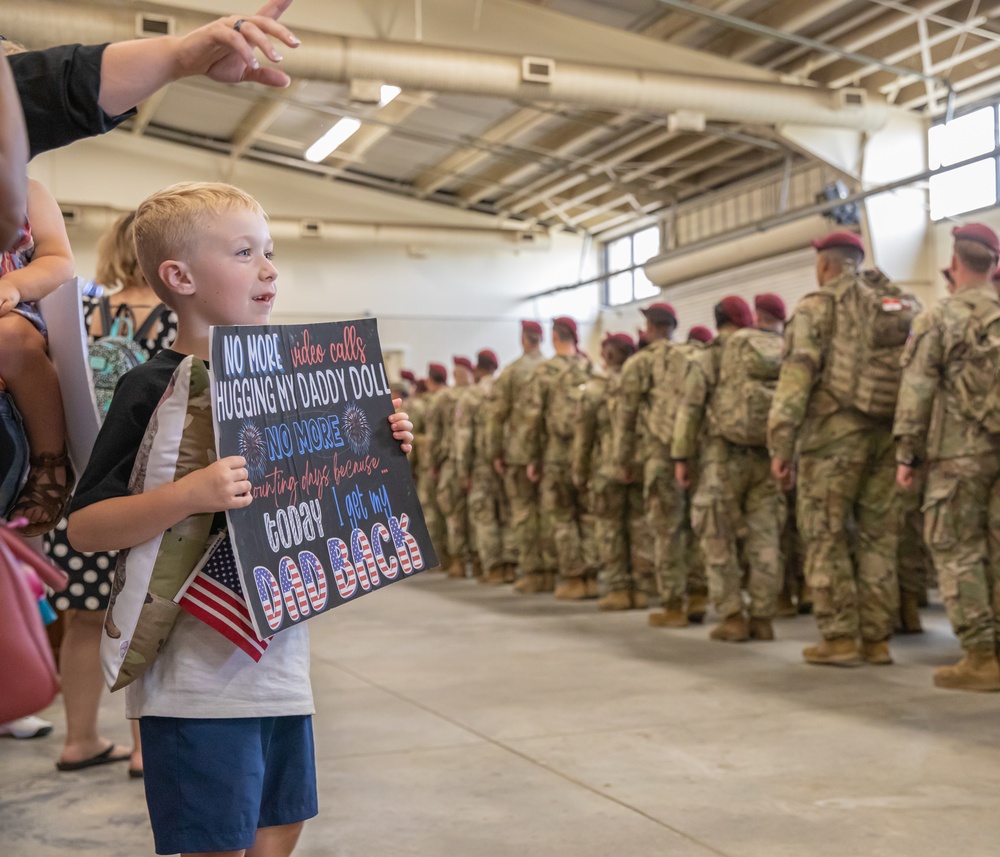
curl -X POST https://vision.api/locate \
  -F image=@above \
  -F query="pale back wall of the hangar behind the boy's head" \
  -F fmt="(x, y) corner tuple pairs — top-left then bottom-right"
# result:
(31, 132), (597, 374)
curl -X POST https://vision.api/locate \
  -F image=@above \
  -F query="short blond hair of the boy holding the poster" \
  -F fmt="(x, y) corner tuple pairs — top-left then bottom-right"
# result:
(132, 182), (267, 306)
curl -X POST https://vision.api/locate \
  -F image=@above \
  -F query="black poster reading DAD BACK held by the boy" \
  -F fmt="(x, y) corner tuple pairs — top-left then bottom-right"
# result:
(211, 319), (437, 640)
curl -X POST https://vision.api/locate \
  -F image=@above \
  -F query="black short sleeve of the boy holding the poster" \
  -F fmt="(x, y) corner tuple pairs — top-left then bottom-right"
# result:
(70, 352), (183, 514)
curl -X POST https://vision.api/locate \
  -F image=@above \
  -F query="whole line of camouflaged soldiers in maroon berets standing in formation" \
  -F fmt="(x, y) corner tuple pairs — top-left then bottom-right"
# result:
(403, 224), (1000, 691)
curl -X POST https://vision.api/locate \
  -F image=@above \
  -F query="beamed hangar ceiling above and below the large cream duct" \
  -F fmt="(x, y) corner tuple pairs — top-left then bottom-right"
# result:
(2, 0), (1000, 238)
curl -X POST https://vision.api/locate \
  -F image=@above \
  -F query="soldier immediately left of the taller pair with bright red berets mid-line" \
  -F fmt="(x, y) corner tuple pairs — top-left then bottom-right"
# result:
(454, 349), (505, 584)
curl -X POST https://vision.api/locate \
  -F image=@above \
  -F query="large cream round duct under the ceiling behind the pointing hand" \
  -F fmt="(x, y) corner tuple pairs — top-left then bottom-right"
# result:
(4, 0), (889, 132)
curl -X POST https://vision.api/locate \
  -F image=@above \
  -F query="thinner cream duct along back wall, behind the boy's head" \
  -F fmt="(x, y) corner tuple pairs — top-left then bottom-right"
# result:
(59, 203), (549, 250)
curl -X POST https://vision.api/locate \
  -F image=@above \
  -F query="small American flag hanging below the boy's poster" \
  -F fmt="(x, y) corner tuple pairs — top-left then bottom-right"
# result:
(174, 531), (270, 661)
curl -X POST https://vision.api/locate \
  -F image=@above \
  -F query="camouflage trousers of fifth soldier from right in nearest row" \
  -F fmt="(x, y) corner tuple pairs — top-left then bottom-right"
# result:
(592, 477), (656, 595)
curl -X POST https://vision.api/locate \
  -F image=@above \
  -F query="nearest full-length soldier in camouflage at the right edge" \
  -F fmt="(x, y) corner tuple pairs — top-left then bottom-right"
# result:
(894, 223), (1000, 691)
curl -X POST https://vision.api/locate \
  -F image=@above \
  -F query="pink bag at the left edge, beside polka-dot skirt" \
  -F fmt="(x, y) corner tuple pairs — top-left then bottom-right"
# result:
(0, 521), (69, 723)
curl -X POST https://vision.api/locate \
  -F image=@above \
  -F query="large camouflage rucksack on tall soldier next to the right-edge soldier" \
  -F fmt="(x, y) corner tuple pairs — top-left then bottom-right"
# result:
(813, 270), (923, 421)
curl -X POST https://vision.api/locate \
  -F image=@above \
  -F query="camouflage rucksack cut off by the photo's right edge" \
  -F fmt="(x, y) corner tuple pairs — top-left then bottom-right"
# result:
(948, 295), (1000, 434)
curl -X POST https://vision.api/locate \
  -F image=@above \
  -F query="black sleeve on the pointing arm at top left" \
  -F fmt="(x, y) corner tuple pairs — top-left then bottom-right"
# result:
(7, 45), (135, 158)
